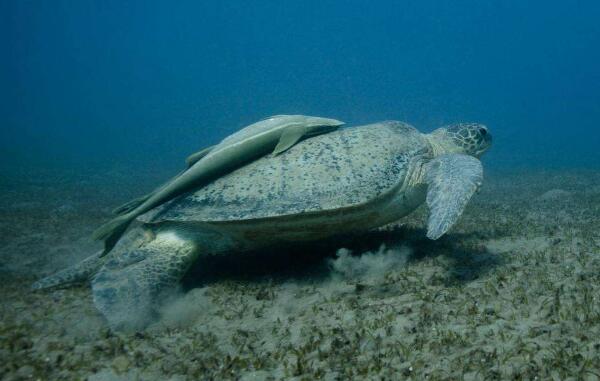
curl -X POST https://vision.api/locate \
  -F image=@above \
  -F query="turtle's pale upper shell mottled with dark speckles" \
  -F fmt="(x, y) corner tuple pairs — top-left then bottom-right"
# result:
(141, 122), (429, 222)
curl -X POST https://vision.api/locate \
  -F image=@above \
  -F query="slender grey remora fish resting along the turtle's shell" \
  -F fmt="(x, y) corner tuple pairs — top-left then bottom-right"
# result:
(92, 115), (344, 254)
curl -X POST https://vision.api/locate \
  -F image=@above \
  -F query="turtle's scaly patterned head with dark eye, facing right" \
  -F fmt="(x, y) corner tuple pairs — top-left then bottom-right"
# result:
(429, 123), (492, 157)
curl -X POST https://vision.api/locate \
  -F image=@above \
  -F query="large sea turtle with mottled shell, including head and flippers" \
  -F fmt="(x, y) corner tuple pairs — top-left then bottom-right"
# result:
(34, 121), (492, 329)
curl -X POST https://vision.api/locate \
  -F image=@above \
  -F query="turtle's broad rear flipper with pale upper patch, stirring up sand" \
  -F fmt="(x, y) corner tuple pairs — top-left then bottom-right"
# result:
(92, 226), (199, 331)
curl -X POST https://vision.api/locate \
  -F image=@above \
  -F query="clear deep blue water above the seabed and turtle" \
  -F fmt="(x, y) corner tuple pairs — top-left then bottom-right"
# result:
(0, 0), (600, 171)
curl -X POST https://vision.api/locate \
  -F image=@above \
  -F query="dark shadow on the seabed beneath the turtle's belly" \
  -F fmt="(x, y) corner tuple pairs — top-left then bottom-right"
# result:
(183, 226), (503, 290)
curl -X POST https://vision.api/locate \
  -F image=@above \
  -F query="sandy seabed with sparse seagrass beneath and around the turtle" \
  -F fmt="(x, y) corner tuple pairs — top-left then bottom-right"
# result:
(0, 170), (600, 381)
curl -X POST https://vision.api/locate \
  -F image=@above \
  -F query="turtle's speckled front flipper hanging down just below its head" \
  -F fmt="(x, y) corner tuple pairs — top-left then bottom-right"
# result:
(425, 154), (483, 240)
